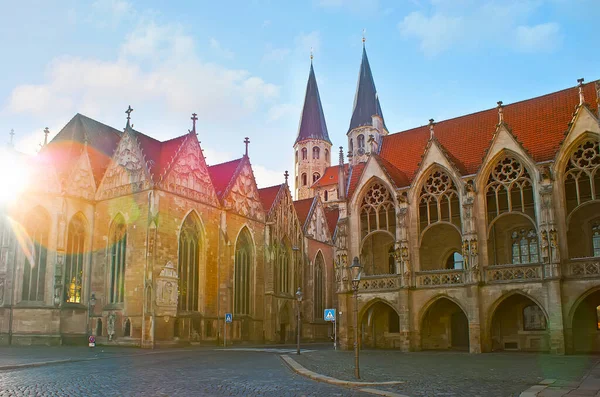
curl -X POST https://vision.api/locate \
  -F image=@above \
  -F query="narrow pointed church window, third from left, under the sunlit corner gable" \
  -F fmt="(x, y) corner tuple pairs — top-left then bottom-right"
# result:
(108, 215), (127, 303)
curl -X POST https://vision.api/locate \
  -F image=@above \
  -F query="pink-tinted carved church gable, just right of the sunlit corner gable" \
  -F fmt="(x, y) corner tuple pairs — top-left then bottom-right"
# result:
(159, 133), (219, 206)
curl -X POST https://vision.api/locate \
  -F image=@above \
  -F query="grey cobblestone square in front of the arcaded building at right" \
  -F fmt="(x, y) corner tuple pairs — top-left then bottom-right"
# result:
(290, 350), (600, 397)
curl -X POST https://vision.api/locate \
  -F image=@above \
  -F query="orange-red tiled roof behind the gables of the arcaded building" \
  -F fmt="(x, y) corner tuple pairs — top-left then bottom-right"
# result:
(382, 82), (598, 184)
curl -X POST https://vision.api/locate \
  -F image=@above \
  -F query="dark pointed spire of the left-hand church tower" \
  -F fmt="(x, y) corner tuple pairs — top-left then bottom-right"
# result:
(295, 58), (331, 144)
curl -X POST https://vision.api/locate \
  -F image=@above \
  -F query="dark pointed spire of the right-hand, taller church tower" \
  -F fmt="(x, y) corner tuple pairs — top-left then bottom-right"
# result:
(348, 41), (387, 131)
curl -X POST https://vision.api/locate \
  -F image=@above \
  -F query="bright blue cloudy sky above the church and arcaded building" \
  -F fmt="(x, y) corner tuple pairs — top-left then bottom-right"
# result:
(0, 0), (600, 187)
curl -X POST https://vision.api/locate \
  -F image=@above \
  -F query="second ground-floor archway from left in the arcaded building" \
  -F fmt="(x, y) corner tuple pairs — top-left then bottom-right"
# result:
(419, 294), (469, 351)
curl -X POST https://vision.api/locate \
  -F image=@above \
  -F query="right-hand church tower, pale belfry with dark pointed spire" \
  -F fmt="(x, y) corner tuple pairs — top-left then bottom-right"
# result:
(346, 37), (388, 165)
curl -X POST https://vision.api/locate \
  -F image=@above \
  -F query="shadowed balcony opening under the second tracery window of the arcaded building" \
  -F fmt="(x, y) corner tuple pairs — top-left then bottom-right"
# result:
(419, 222), (462, 271)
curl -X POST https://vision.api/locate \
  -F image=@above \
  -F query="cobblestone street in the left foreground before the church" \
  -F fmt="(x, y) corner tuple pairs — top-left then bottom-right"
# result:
(0, 348), (372, 397)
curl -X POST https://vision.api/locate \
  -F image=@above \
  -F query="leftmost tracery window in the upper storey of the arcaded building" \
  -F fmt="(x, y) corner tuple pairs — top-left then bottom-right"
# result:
(360, 182), (396, 237)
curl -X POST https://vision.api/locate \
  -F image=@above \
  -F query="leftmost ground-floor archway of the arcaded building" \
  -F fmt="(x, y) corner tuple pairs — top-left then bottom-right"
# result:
(358, 298), (400, 349)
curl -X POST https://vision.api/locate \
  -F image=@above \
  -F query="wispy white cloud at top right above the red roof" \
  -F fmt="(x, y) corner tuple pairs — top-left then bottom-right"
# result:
(398, 0), (561, 56)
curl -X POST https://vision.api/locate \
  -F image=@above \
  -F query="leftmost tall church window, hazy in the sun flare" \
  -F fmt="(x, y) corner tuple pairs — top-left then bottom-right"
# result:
(21, 209), (50, 302)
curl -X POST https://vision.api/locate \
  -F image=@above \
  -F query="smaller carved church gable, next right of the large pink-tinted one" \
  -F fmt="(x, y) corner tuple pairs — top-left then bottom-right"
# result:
(223, 156), (265, 221)
